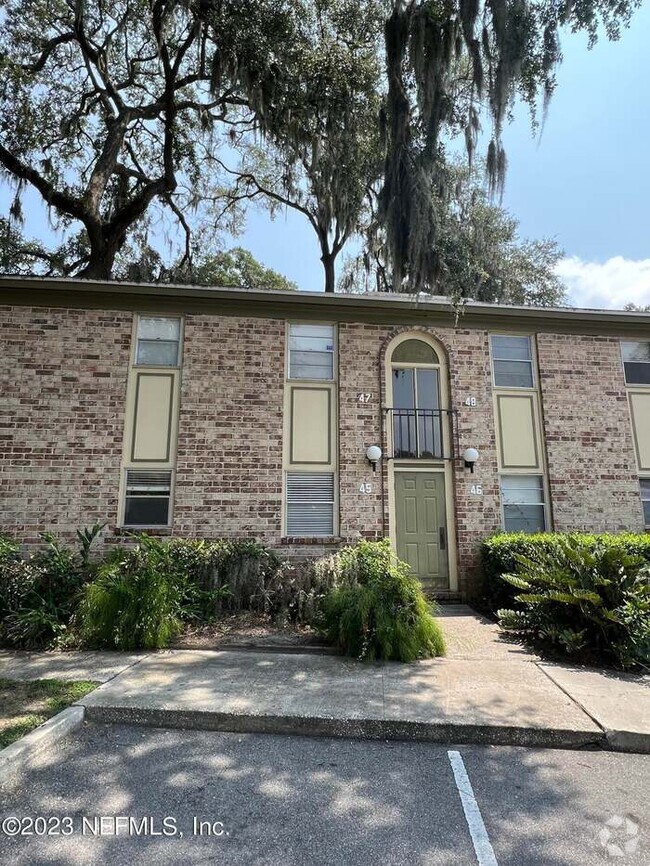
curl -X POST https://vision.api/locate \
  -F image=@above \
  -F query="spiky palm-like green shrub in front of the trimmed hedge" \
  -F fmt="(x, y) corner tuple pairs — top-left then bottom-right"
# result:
(498, 536), (650, 667)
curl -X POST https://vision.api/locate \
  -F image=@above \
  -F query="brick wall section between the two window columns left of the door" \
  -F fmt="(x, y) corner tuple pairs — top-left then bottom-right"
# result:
(174, 315), (285, 543)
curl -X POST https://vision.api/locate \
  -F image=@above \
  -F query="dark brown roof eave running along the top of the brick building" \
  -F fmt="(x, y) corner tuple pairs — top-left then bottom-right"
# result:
(0, 276), (650, 337)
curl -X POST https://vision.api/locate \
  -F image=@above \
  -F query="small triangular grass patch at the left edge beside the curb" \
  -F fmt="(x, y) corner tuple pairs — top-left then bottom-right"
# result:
(0, 679), (98, 749)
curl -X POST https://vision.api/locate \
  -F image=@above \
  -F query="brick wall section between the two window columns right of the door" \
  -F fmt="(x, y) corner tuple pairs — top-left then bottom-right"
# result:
(537, 334), (643, 532)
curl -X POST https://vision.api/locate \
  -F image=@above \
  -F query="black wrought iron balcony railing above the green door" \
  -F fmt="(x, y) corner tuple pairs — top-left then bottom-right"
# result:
(386, 409), (455, 460)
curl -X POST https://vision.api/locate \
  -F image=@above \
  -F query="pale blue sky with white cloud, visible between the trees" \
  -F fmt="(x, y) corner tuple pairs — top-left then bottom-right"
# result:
(5, 4), (650, 307)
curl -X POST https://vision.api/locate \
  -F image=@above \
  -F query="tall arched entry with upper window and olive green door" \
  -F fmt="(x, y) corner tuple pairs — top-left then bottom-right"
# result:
(386, 333), (456, 591)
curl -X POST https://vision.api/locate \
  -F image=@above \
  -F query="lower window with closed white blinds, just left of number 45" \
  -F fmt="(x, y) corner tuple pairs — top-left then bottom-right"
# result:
(286, 472), (334, 536)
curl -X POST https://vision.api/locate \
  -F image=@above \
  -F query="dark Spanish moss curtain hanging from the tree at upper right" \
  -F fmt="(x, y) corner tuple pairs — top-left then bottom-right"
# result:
(379, 0), (640, 298)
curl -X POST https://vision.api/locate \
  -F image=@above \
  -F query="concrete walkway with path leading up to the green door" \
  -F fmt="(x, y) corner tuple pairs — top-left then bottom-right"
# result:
(0, 605), (650, 752)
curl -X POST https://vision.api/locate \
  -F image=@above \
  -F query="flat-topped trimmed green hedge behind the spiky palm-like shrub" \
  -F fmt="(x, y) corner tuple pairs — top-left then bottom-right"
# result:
(481, 532), (650, 615)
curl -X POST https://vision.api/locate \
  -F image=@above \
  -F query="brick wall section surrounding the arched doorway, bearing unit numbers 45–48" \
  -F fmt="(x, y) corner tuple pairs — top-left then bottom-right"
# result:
(339, 324), (501, 594)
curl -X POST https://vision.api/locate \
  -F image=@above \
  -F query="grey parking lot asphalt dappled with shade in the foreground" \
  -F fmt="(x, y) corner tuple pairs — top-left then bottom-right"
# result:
(0, 724), (650, 866)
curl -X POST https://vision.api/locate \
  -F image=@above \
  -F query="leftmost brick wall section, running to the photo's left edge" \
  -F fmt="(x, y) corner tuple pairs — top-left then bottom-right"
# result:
(0, 307), (132, 541)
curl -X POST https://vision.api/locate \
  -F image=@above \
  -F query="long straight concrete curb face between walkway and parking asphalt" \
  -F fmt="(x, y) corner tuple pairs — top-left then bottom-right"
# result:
(86, 704), (607, 749)
